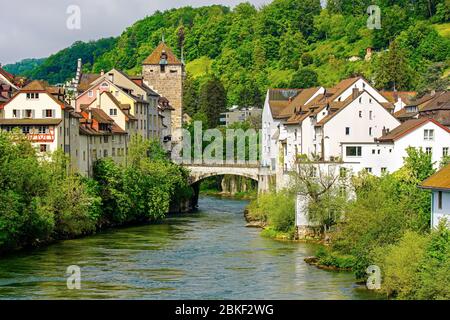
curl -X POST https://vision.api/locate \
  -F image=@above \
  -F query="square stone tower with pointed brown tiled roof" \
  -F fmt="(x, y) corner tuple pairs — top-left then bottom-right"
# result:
(142, 41), (186, 141)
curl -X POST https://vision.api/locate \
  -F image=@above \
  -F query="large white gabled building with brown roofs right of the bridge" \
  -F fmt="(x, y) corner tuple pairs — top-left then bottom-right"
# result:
(262, 77), (400, 185)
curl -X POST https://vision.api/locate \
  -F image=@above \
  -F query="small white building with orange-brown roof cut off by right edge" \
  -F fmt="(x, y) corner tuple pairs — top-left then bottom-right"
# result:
(421, 164), (450, 228)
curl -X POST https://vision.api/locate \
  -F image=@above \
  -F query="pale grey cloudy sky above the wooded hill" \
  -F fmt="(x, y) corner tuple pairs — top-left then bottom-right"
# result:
(0, 0), (271, 65)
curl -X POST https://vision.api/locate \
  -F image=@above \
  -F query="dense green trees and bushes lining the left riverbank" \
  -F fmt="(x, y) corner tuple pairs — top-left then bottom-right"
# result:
(0, 132), (191, 253)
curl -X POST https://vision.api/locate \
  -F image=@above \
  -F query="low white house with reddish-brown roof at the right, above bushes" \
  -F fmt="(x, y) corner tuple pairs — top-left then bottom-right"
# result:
(341, 118), (450, 175)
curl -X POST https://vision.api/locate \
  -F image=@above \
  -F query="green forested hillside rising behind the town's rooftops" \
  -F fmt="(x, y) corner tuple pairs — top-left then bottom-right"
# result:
(8, 0), (450, 107)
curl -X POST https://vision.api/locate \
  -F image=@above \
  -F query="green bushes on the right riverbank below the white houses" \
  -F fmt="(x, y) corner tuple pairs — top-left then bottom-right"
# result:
(294, 148), (450, 299)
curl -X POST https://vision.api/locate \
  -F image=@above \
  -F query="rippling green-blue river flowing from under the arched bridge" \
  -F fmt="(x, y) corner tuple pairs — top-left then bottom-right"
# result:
(0, 197), (374, 299)
